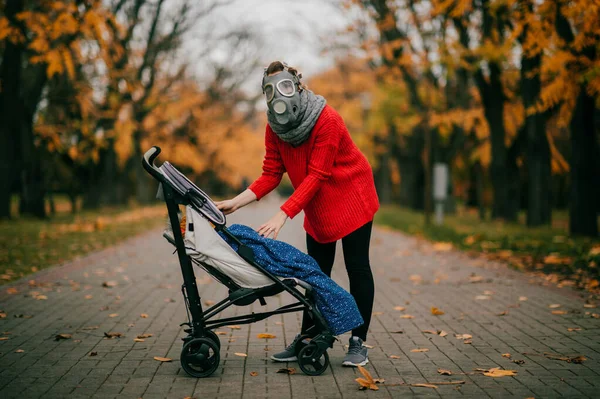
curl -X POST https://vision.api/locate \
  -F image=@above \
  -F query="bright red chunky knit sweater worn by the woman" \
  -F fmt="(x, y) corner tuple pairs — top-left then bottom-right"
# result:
(249, 105), (379, 243)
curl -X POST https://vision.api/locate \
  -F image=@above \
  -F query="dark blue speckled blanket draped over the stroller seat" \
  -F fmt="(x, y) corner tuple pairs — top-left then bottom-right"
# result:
(219, 224), (364, 335)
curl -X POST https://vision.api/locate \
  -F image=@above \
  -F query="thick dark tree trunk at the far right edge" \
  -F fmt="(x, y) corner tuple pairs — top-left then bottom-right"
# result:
(569, 86), (600, 237)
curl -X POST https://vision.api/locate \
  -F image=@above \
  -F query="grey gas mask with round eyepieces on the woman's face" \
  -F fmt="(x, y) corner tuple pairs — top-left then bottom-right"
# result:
(262, 67), (301, 126)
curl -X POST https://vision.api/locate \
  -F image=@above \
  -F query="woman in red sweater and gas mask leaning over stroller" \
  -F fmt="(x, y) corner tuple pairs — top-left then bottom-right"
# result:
(217, 61), (379, 366)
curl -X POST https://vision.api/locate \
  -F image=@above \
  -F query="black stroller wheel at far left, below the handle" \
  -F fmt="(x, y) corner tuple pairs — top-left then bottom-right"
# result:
(181, 338), (220, 378)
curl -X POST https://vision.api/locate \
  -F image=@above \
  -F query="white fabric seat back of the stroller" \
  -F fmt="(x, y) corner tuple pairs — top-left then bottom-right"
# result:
(184, 205), (274, 288)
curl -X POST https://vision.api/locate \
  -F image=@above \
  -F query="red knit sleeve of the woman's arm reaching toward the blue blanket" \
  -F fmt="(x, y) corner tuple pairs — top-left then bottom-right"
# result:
(281, 118), (346, 219)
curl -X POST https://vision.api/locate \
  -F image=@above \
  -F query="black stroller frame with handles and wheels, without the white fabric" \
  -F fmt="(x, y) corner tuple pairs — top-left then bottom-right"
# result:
(142, 146), (335, 378)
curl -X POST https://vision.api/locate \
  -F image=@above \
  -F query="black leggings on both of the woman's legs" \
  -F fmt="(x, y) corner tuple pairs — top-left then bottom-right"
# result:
(302, 221), (375, 341)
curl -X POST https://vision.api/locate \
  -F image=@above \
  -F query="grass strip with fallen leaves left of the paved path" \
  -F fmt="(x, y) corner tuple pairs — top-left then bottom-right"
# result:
(0, 204), (167, 285)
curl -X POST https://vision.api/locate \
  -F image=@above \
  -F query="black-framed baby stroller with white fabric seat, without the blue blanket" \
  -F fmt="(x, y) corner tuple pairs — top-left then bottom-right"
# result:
(142, 146), (335, 378)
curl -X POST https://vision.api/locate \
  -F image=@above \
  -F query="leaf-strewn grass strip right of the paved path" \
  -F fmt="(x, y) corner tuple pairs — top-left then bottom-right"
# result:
(375, 206), (600, 294)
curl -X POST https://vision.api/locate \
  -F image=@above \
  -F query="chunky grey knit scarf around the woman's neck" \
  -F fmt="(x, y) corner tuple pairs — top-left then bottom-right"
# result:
(267, 89), (326, 147)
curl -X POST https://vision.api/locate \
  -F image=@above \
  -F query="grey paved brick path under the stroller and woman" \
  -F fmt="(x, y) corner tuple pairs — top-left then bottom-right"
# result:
(0, 198), (600, 399)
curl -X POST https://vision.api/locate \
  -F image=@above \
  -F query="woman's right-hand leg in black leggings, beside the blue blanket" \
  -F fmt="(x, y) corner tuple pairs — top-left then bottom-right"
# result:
(342, 221), (375, 341)
